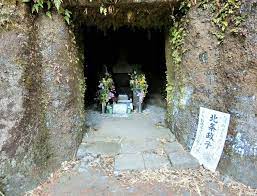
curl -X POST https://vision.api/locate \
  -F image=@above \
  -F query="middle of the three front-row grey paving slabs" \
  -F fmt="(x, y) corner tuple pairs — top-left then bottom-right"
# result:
(143, 153), (171, 169)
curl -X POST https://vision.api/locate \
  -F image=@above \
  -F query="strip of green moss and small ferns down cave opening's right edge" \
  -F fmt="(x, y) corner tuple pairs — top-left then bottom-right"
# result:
(166, 0), (191, 125)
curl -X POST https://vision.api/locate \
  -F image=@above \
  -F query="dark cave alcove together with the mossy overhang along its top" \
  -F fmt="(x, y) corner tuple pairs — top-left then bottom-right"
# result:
(70, 2), (174, 106)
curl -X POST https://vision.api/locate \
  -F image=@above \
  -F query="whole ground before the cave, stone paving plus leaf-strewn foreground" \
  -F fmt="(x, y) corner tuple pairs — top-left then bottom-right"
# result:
(26, 107), (257, 196)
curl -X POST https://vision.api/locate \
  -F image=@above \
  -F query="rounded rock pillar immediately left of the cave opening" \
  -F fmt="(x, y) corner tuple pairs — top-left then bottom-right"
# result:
(36, 15), (85, 166)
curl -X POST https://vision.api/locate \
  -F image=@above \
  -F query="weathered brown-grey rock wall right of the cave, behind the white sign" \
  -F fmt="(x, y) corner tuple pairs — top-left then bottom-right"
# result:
(166, 2), (257, 187)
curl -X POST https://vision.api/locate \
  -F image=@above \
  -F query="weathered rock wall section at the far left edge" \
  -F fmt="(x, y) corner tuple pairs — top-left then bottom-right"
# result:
(0, 1), (31, 192)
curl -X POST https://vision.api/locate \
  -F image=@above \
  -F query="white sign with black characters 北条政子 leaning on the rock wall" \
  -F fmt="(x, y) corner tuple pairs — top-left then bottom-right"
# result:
(191, 107), (230, 172)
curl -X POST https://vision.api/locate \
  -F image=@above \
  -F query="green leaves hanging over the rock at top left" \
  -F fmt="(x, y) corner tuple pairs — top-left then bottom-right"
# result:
(22, 0), (72, 24)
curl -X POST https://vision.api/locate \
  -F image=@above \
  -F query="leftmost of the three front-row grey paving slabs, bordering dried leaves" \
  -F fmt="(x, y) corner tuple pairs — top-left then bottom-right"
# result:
(114, 153), (145, 172)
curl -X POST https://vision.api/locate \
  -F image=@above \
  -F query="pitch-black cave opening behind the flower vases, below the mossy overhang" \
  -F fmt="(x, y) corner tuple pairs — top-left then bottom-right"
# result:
(83, 26), (166, 108)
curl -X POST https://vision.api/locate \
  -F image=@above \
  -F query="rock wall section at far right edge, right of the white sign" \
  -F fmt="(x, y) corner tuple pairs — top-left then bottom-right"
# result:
(217, 3), (257, 188)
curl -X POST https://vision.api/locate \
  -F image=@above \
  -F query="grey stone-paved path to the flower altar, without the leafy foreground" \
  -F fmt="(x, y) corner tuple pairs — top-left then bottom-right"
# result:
(77, 105), (199, 174)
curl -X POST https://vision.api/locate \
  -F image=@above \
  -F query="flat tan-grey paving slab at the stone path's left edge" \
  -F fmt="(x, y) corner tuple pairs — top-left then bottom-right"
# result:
(77, 141), (120, 155)
